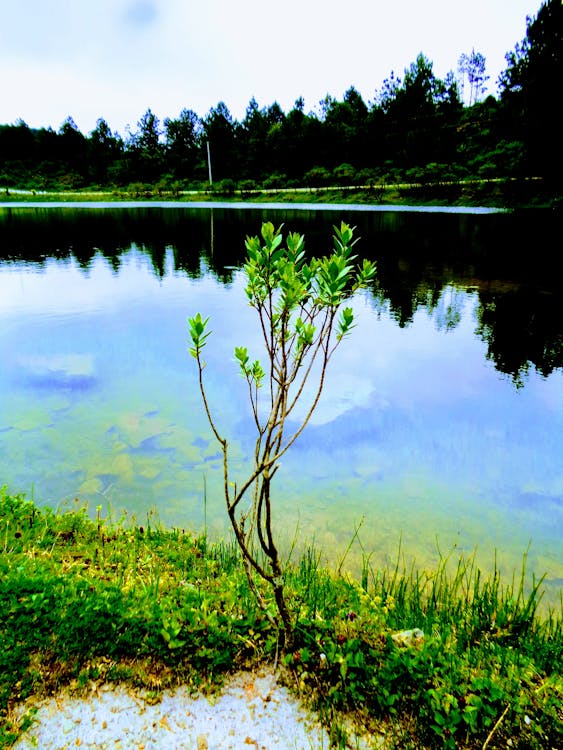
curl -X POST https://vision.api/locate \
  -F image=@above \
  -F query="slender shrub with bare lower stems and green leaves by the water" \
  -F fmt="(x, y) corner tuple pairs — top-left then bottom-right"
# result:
(188, 222), (375, 645)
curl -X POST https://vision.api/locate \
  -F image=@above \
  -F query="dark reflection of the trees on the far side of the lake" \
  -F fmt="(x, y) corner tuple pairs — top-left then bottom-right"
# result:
(0, 204), (563, 385)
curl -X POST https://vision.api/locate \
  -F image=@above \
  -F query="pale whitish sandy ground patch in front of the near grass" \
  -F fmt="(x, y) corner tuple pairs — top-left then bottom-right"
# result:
(14, 670), (383, 750)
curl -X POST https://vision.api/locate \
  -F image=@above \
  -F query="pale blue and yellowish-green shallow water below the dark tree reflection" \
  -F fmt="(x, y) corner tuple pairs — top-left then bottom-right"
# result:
(0, 209), (563, 599)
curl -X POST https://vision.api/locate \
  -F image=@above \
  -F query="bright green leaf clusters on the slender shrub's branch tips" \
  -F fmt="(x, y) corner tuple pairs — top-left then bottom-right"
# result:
(188, 222), (375, 412)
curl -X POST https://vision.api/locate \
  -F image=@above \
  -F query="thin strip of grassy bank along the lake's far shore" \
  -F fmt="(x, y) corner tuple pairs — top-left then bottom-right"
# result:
(0, 178), (560, 208)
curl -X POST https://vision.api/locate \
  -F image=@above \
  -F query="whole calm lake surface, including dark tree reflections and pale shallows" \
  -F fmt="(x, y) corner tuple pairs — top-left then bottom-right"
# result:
(0, 205), (563, 599)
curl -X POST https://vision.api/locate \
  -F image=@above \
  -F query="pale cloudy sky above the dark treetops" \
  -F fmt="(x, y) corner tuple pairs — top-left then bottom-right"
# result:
(0, 0), (541, 136)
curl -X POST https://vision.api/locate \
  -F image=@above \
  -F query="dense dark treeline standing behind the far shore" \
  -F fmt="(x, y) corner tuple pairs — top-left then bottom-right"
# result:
(0, 0), (563, 192)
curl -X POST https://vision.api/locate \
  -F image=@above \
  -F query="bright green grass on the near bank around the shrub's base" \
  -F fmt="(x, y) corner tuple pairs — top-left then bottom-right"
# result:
(0, 489), (563, 750)
